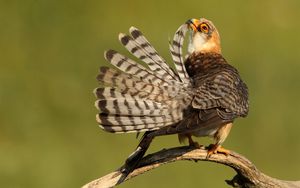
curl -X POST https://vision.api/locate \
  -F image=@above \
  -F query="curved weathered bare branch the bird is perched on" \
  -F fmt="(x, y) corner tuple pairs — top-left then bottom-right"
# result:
(82, 146), (300, 188)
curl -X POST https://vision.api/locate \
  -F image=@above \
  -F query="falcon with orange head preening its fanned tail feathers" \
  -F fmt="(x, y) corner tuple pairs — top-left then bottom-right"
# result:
(94, 18), (249, 181)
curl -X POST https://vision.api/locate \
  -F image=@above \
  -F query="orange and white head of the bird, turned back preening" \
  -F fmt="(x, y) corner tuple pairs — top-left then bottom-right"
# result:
(186, 18), (221, 54)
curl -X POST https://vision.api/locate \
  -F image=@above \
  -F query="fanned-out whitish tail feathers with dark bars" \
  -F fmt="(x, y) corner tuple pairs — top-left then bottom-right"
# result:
(94, 27), (192, 133)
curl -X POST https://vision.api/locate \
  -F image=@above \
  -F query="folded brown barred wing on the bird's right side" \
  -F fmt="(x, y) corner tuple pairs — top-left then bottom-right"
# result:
(192, 69), (248, 119)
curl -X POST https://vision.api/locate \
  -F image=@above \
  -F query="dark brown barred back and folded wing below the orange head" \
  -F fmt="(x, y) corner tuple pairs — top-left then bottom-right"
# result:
(186, 53), (249, 119)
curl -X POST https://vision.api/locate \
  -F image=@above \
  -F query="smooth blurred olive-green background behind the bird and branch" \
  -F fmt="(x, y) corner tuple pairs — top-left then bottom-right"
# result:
(0, 0), (300, 188)
